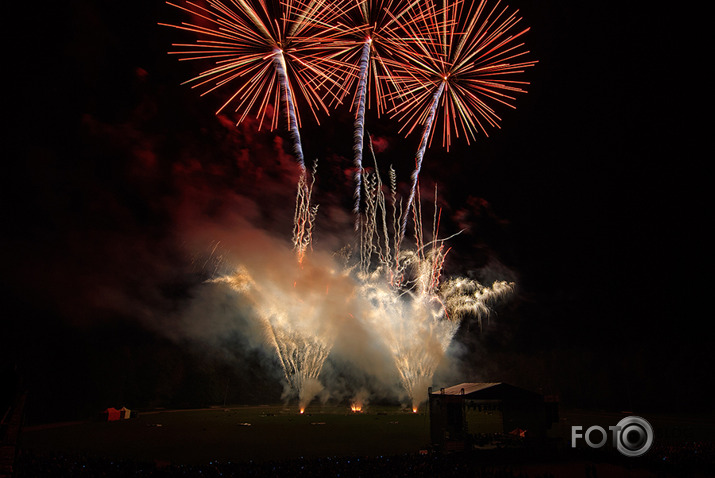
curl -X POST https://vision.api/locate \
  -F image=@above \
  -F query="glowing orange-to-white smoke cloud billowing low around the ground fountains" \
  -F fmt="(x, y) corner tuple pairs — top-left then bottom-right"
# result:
(154, 154), (511, 409)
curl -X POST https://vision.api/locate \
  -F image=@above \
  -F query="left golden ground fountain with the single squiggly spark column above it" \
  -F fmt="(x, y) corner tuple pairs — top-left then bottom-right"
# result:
(207, 166), (353, 413)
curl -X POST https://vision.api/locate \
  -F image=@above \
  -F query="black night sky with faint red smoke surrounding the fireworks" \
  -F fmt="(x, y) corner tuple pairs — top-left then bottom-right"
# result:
(0, 0), (713, 421)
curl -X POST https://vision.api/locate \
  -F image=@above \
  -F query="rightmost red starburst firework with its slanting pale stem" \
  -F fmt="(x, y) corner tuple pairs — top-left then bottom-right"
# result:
(385, 0), (536, 235)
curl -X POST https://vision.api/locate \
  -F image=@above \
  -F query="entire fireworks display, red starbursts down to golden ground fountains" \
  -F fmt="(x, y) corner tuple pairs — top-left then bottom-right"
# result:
(163, 0), (536, 411)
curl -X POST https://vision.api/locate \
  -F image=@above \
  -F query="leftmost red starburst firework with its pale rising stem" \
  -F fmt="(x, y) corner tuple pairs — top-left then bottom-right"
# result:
(162, 0), (352, 170)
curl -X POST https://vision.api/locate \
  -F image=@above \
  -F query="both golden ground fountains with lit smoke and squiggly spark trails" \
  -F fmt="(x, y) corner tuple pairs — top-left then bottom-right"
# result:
(182, 141), (513, 410)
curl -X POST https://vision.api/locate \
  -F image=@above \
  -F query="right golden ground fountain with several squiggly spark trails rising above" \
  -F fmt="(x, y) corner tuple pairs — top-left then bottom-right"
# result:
(358, 165), (514, 411)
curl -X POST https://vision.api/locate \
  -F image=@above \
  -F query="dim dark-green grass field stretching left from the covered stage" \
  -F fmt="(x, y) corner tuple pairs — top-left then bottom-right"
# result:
(21, 406), (429, 464)
